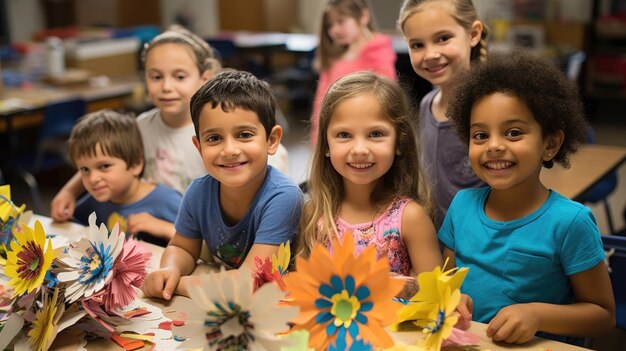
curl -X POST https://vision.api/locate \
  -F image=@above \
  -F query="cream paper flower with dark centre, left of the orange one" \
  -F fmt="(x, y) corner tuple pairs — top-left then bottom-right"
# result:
(183, 267), (298, 351)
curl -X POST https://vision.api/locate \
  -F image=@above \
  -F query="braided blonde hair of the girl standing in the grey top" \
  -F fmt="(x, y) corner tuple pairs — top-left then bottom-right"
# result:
(397, 0), (489, 62)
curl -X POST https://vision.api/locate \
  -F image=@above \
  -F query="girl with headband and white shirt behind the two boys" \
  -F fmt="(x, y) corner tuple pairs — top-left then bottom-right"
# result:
(51, 26), (287, 223)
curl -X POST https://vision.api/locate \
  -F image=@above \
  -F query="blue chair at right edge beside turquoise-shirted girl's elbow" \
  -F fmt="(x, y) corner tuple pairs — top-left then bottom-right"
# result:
(602, 235), (626, 330)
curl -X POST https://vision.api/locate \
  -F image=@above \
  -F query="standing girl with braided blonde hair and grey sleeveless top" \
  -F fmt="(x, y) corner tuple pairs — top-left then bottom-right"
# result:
(398, 0), (487, 228)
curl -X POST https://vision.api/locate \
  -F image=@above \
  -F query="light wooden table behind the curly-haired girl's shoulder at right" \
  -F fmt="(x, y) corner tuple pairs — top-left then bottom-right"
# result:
(541, 144), (626, 200)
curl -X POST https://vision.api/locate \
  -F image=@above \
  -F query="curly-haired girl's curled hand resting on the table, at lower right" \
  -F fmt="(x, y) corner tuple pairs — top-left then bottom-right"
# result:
(487, 304), (539, 344)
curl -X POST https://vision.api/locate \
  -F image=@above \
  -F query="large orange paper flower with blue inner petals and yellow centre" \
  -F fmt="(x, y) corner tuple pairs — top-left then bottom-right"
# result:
(285, 233), (404, 350)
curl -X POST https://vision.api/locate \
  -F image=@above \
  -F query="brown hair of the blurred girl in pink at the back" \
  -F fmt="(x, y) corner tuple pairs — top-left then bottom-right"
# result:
(315, 0), (376, 71)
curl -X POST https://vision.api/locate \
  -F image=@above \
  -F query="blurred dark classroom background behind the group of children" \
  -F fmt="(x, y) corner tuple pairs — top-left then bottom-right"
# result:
(0, 0), (626, 350)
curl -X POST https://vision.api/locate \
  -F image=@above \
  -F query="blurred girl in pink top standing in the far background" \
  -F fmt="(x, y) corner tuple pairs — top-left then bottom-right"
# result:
(311, 0), (396, 146)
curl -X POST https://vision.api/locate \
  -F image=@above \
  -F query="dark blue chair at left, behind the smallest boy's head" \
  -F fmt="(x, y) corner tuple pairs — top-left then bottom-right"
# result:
(5, 99), (87, 213)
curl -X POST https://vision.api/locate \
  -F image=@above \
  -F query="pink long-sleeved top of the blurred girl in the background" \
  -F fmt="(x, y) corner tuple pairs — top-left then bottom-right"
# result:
(311, 33), (396, 145)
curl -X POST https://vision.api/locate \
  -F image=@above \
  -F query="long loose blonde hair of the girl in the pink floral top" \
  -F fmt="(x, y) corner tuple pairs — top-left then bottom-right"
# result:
(297, 71), (433, 256)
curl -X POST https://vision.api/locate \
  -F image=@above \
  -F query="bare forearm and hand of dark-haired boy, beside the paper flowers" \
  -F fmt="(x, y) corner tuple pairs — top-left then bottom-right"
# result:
(141, 233), (202, 300)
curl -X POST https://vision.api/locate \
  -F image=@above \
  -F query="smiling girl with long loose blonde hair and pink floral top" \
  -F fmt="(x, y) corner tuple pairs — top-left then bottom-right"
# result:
(298, 72), (441, 296)
